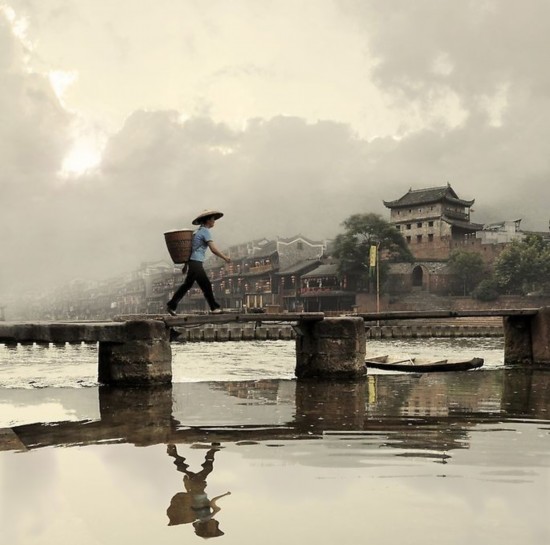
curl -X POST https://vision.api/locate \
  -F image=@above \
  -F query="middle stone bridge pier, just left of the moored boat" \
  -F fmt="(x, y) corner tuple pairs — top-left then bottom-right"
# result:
(295, 317), (367, 380)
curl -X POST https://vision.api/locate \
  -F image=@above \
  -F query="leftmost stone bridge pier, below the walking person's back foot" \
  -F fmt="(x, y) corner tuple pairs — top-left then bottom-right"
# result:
(98, 320), (172, 385)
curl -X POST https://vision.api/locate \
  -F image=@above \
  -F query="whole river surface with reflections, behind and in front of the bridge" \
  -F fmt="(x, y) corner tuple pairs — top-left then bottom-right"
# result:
(0, 338), (550, 545)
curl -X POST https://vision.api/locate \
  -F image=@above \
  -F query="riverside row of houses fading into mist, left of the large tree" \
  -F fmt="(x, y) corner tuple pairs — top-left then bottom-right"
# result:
(27, 235), (355, 320)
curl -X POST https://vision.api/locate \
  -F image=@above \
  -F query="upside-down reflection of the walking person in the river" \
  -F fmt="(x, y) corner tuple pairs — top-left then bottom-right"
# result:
(166, 443), (231, 538)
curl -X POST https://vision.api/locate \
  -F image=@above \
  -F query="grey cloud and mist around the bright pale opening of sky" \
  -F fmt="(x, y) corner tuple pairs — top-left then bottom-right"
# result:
(0, 0), (550, 294)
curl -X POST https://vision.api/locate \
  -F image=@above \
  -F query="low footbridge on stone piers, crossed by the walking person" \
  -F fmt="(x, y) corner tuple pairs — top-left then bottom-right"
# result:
(0, 307), (550, 385)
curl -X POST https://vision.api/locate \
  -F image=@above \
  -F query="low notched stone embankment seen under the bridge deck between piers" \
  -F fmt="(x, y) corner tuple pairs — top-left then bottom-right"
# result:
(176, 318), (504, 342)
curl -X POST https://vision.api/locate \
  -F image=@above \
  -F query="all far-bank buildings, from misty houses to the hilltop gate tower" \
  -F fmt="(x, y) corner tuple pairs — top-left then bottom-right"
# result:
(11, 184), (548, 319)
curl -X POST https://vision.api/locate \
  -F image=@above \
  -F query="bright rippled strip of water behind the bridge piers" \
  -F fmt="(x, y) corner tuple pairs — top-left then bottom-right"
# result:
(0, 337), (504, 388)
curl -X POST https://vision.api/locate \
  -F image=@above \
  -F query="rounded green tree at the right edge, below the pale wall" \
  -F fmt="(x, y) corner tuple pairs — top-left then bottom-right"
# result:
(494, 234), (550, 295)
